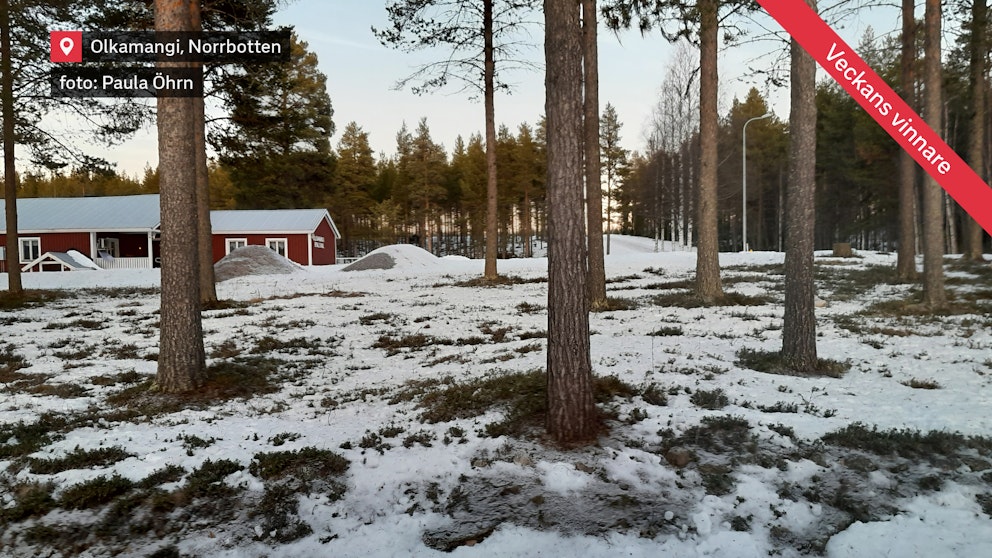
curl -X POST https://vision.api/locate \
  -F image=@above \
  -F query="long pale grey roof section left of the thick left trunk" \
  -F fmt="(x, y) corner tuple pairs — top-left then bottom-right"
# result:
(0, 194), (159, 233)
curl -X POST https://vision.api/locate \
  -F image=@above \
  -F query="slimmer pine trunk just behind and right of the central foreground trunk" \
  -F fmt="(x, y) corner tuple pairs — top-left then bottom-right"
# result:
(582, 0), (608, 309)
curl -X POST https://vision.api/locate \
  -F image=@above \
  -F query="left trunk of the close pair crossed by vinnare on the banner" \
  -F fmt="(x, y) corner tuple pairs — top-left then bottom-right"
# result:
(896, 0), (916, 281)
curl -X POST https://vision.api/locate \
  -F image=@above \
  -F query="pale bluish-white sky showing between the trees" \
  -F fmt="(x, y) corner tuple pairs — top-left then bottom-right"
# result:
(64, 0), (899, 175)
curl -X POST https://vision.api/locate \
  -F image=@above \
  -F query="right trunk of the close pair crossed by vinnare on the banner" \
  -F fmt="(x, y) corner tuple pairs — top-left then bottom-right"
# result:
(923, 0), (947, 310)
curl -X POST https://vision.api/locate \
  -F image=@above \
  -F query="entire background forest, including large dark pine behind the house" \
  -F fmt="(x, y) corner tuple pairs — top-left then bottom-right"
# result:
(7, 1), (992, 257)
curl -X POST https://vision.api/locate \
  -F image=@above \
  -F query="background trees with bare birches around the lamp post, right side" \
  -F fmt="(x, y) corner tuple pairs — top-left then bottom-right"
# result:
(615, 26), (992, 253)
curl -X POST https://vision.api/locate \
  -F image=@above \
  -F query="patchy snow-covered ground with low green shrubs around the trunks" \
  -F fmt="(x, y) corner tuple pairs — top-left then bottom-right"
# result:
(0, 236), (992, 558)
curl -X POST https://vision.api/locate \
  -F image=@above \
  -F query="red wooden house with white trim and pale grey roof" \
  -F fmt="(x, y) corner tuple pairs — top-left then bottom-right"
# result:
(0, 194), (340, 272)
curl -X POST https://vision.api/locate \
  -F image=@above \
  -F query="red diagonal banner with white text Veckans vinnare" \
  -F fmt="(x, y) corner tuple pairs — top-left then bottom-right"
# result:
(758, 0), (992, 234)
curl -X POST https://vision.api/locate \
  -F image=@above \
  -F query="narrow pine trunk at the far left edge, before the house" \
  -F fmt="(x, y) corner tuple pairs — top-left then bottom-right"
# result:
(0, 0), (24, 295)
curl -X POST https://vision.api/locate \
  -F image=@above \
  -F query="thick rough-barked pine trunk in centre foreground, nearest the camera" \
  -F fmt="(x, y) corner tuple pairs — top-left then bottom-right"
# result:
(544, 0), (598, 443)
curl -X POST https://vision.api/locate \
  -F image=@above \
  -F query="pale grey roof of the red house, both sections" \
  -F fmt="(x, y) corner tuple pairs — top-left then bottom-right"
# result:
(0, 194), (340, 237)
